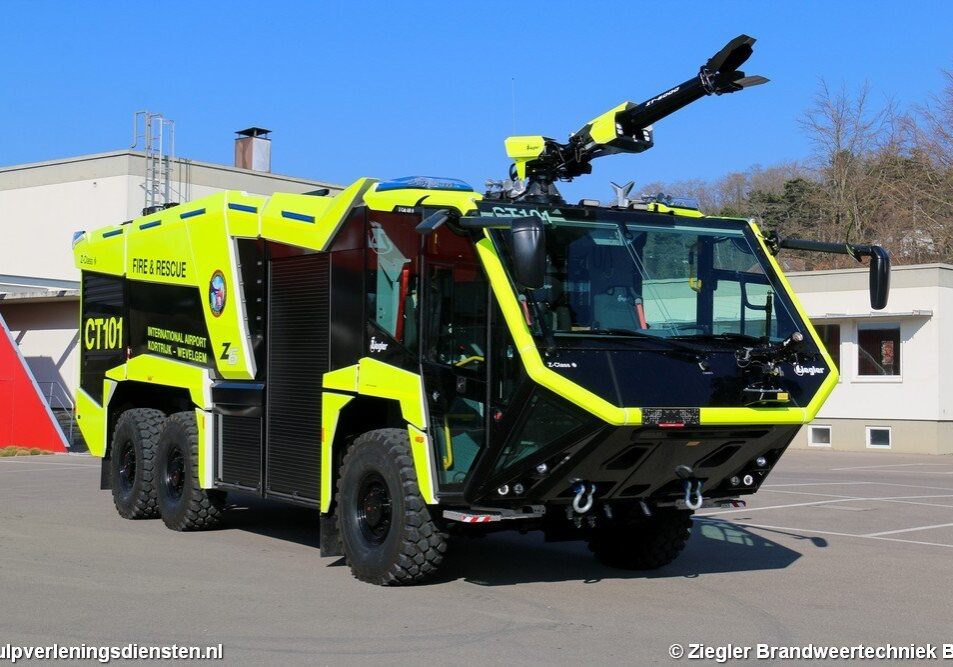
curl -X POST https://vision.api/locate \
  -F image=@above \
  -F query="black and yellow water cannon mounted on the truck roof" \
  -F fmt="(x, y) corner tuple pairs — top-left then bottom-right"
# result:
(494, 35), (768, 203)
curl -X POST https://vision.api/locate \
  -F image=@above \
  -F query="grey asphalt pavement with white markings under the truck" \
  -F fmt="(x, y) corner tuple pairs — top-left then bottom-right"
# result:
(0, 451), (953, 665)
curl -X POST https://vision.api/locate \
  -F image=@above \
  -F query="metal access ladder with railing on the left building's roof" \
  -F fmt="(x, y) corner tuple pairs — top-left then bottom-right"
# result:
(130, 111), (176, 215)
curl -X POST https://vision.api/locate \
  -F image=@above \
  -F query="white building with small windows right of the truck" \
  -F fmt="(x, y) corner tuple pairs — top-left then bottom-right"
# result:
(789, 264), (953, 454)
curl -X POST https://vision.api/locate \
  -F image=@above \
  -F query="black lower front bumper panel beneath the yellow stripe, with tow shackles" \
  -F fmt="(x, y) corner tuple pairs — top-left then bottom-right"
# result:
(465, 388), (800, 505)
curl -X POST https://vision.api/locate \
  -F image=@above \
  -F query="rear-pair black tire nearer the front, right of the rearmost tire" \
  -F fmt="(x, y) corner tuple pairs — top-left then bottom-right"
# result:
(155, 412), (226, 531)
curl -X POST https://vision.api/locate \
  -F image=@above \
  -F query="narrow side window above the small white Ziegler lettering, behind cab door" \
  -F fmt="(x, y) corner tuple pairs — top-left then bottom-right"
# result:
(366, 213), (420, 349)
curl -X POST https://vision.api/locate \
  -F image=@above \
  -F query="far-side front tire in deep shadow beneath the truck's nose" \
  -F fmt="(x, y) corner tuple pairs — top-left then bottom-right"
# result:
(589, 510), (692, 570)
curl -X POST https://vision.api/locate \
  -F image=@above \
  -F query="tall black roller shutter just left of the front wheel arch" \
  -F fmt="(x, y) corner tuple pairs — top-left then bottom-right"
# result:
(265, 253), (331, 502)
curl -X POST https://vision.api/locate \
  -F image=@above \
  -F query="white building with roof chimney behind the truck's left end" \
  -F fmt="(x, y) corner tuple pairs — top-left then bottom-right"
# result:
(0, 137), (341, 446)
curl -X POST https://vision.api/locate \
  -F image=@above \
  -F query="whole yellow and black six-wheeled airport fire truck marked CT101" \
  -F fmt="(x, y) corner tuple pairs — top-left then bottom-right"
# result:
(74, 35), (890, 585)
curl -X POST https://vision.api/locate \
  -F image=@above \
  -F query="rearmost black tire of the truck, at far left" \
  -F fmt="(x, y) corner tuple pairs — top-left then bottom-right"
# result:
(109, 408), (165, 519)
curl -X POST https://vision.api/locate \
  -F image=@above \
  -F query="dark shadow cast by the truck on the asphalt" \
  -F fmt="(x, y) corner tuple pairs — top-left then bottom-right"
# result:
(222, 496), (827, 586)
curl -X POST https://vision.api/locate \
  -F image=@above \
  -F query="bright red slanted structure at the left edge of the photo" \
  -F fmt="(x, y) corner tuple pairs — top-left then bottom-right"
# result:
(0, 316), (67, 452)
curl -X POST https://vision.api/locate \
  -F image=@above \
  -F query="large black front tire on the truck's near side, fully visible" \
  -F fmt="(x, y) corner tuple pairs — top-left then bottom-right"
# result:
(337, 429), (447, 586)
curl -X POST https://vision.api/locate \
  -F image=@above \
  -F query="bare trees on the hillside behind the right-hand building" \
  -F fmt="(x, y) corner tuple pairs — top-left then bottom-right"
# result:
(628, 71), (953, 268)
